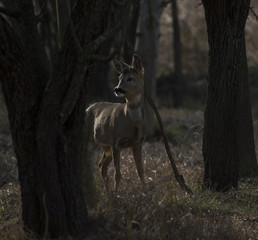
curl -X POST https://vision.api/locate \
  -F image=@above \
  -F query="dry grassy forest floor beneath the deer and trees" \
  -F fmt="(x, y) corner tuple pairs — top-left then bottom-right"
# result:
(0, 110), (258, 240)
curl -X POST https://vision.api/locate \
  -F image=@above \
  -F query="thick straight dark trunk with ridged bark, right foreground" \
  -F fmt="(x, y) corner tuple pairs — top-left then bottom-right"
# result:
(203, 0), (255, 191)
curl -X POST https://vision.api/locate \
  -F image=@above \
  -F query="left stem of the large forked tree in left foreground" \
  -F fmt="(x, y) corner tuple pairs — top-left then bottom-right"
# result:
(1, 0), (49, 232)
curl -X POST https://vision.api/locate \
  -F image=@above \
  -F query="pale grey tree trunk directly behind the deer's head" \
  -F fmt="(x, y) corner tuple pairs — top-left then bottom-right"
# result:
(135, 0), (162, 134)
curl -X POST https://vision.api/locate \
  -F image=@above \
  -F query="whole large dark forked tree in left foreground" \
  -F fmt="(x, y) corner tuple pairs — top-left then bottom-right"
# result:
(0, 0), (128, 237)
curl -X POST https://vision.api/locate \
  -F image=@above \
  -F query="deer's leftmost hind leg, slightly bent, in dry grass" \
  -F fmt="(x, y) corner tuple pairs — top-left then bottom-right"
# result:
(99, 148), (112, 191)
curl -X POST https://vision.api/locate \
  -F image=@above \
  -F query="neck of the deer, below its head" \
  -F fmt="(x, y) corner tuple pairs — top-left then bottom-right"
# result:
(125, 95), (144, 122)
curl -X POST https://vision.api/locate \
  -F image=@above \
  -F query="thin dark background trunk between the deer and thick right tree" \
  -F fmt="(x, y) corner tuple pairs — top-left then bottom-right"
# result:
(171, 0), (183, 108)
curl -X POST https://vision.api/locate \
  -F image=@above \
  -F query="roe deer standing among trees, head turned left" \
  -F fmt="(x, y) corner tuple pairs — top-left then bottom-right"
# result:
(86, 55), (146, 191)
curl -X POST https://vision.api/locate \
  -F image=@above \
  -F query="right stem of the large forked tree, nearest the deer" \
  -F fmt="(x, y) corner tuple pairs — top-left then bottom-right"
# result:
(37, 0), (110, 236)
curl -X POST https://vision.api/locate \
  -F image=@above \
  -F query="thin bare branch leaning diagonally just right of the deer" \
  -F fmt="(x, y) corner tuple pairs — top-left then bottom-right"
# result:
(144, 88), (193, 194)
